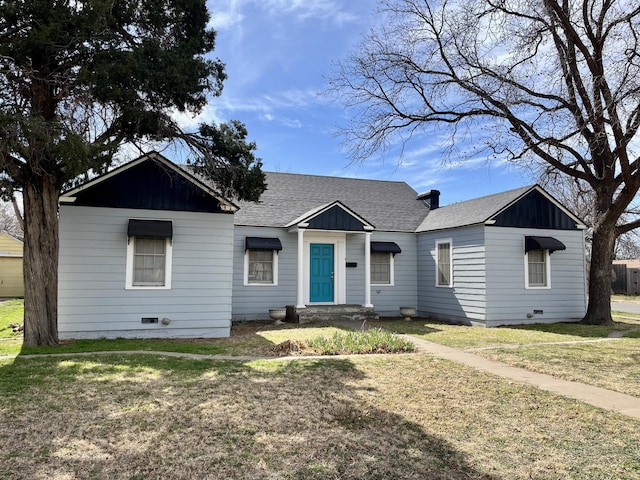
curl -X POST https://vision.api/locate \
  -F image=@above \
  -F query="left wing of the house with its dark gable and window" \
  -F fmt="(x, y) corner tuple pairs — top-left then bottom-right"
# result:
(58, 153), (238, 339)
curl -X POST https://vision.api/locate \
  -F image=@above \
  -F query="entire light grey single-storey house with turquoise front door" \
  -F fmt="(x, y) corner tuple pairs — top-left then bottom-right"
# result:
(59, 153), (586, 338)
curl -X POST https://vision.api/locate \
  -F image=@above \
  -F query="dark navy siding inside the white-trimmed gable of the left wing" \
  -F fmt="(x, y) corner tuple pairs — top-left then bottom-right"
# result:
(73, 159), (228, 213)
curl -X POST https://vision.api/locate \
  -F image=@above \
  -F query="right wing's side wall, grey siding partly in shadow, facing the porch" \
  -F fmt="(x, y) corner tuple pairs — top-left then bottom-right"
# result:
(417, 225), (487, 324)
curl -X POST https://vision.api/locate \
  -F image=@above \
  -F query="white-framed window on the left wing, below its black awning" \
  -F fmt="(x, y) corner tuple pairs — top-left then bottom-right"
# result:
(126, 237), (172, 289)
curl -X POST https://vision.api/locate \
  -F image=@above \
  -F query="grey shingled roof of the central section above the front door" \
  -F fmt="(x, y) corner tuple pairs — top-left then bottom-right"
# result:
(235, 172), (429, 232)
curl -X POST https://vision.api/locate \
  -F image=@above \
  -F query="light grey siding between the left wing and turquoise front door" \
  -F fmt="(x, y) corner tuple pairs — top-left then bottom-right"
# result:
(232, 226), (298, 321)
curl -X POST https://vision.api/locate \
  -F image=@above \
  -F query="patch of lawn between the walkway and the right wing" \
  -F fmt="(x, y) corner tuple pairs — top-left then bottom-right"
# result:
(380, 314), (640, 397)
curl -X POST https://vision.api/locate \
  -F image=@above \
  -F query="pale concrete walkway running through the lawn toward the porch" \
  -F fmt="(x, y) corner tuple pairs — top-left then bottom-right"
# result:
(334, 321), (640, 419)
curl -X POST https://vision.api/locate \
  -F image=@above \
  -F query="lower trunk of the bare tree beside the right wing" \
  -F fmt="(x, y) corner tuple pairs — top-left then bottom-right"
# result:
(582, 221), (616, 325)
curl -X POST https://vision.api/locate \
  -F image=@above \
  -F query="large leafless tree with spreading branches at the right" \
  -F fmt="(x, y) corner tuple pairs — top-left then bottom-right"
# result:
(329, 0), (640, 324)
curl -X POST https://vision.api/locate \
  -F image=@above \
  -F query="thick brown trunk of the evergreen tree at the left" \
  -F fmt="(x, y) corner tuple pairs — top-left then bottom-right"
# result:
(22, 176), (59, 346)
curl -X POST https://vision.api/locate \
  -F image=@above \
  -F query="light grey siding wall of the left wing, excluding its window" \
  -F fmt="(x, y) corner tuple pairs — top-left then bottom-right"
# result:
(58, 205), (233, 339)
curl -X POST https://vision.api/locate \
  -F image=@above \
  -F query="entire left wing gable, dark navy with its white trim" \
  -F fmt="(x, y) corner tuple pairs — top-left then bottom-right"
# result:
(60, 152), (237, 213)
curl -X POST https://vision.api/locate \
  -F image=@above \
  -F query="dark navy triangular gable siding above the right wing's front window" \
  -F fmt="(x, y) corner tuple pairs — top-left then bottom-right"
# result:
(494, 190), (578, 230)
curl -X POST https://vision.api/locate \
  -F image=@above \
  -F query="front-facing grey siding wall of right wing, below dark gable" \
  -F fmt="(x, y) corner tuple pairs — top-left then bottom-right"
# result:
(485, 226), (586, 326)
